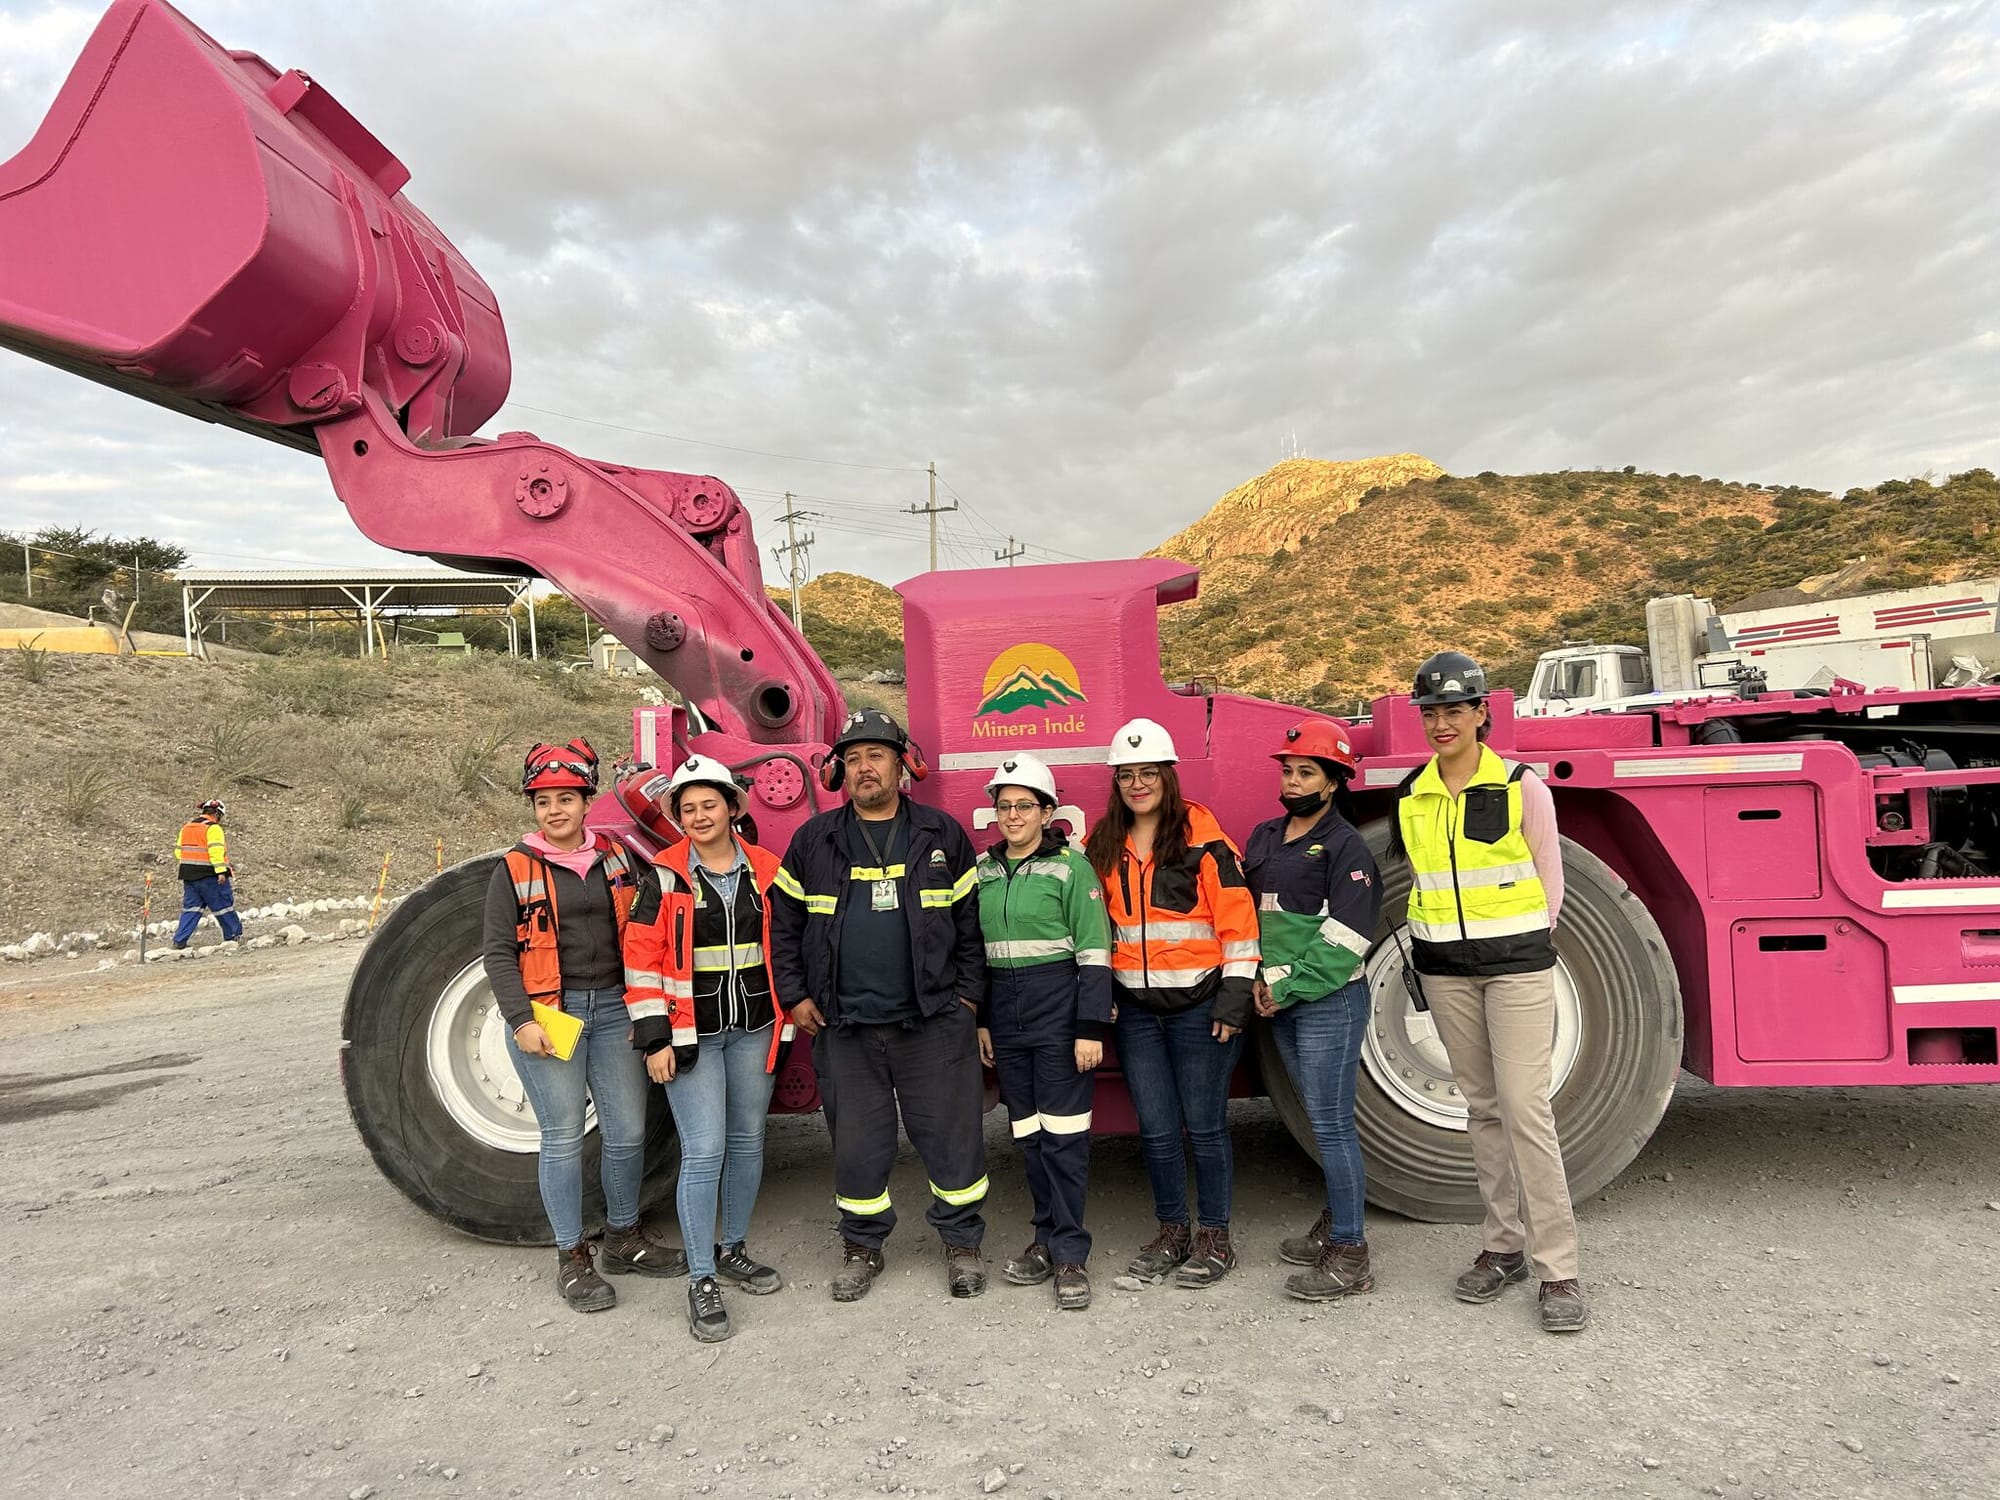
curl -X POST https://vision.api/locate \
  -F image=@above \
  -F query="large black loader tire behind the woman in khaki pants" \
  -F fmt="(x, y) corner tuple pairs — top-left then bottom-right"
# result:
(1256, 822), (1682, 1224)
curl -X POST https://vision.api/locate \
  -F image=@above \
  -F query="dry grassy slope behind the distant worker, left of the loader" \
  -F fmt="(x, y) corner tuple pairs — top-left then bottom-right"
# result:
(0, 656), (638, 942)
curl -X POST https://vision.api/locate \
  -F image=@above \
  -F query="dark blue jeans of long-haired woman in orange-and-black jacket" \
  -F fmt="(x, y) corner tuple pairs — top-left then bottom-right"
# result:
(1118, 1000), (1244, 1228)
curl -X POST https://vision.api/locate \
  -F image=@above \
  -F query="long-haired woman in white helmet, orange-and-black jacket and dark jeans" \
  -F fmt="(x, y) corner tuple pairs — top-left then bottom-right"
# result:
(1086, 718), (1258, 1286)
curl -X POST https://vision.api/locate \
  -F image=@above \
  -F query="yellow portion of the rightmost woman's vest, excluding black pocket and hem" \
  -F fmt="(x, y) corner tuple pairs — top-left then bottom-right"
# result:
(1396, 746), (1548, 942)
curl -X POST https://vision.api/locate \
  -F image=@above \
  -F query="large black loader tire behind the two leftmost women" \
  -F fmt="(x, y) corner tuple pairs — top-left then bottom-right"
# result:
(340, 854), (680, 1244)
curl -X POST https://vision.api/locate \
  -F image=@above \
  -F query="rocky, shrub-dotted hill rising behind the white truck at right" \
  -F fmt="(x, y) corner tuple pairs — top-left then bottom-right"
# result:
(1162, 468), (2000, 708)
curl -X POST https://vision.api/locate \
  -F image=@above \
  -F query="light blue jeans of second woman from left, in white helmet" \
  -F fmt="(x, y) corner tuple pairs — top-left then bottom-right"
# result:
(666, 1026), (778, 1282)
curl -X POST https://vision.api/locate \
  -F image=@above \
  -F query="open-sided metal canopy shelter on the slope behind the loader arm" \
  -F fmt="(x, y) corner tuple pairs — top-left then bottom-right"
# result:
(178, 568), (542, 658)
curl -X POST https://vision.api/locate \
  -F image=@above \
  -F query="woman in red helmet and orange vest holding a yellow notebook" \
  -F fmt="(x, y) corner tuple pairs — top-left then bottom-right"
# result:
(484, 740), (688, 1312)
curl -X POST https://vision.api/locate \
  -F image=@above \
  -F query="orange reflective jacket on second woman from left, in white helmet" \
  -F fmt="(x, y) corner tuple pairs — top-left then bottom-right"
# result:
(624, 836), (792, 1072)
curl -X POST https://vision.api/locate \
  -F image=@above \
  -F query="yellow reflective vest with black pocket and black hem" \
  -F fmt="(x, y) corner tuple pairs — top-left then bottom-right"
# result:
(1396, 746), (1556, 974)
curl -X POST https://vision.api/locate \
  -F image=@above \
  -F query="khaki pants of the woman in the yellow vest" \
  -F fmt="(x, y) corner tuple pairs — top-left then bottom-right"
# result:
(1424, 968), (1576, 1282)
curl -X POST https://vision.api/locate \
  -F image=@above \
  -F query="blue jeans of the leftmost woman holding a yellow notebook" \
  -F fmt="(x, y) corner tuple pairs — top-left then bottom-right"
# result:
(506, 988), (650, 1250)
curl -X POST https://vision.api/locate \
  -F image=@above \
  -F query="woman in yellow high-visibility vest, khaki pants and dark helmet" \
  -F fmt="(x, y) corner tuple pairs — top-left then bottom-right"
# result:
(1396, 652), (1590, 1334)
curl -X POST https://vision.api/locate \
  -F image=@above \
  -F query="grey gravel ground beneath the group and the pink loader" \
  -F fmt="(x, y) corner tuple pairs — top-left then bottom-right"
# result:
(0, 946), (2000, 1500)
